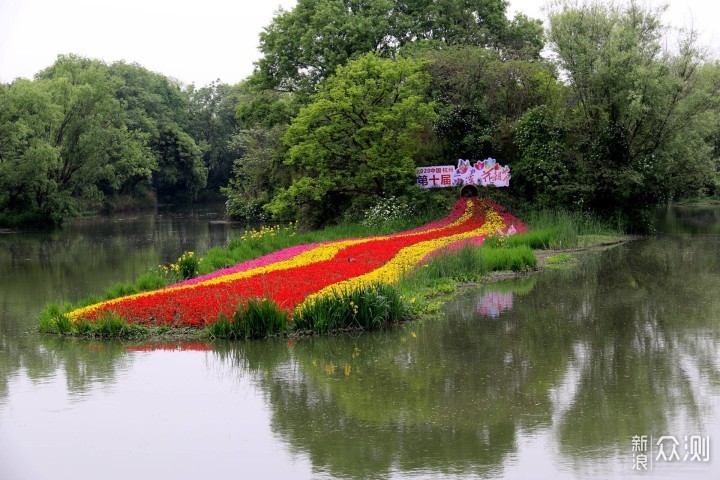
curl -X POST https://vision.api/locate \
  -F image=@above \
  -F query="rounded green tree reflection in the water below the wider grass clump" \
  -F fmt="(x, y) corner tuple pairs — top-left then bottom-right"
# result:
(211, 276), (569, 477)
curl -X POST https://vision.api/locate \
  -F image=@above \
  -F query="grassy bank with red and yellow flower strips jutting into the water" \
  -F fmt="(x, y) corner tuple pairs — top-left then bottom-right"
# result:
(39, 200), (628, 338)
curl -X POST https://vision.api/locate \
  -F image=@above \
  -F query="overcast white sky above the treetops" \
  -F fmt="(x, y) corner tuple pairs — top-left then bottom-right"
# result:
(0, 0), (720, 86)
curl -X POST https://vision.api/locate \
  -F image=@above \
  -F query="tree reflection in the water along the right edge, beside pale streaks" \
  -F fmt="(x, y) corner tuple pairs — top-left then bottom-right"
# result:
(543, 238), (720, 457)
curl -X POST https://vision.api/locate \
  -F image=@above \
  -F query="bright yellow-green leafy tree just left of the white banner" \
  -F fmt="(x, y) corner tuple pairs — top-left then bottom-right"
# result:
(268, 54), (436, 225)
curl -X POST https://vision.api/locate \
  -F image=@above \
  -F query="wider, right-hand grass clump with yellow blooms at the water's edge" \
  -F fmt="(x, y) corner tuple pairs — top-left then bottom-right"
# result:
(292, 283), (414, 333)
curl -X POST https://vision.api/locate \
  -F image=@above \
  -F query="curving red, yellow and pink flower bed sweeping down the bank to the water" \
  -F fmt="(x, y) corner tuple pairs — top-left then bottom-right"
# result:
(68, 199), (526, 327)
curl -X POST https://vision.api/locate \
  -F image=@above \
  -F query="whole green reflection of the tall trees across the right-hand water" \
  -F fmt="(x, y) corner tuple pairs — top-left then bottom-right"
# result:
(221, 239), (720, 477)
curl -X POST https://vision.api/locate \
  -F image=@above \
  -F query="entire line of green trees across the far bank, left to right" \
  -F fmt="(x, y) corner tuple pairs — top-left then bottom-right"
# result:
(0, 0), (720, 229)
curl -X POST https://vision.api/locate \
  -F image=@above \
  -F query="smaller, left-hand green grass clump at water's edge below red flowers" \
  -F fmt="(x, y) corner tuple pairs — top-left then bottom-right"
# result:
(207, 298), (288, 340)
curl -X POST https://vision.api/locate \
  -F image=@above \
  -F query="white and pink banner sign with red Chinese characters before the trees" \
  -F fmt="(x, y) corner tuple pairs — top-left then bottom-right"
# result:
(415, 158), (510, 188)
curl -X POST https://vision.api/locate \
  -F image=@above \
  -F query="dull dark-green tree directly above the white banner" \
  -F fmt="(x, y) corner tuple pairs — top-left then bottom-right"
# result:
(424, 46), (562, 162)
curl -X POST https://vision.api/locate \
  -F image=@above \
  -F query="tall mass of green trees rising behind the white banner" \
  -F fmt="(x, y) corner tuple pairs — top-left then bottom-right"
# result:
(225, 0), (720, 230)
